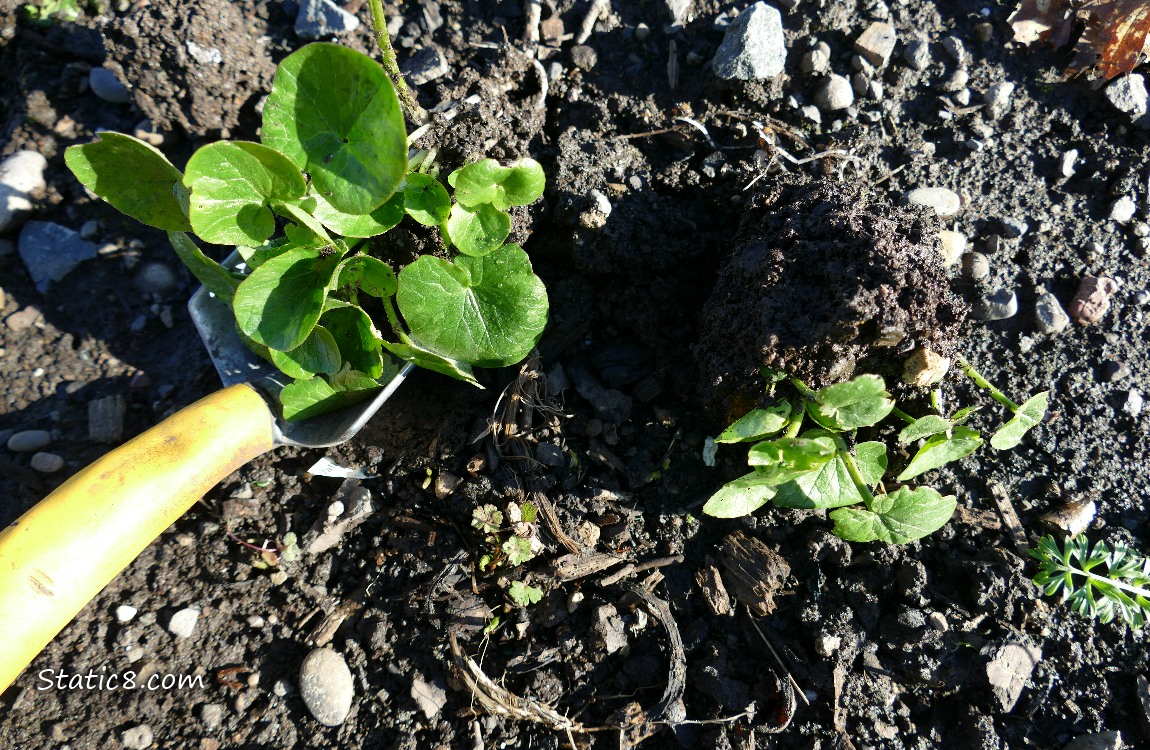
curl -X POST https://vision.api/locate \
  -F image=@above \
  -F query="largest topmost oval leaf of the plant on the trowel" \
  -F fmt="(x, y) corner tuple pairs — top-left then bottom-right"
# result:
(261, 43), (407, 214)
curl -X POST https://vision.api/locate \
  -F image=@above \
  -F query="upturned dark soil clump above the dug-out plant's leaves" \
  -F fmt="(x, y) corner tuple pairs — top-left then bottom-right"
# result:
(695, 182), (967, 416)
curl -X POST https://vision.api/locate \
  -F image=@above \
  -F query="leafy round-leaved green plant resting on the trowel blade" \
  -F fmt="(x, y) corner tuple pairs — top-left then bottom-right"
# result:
(64, 43), (547, 420)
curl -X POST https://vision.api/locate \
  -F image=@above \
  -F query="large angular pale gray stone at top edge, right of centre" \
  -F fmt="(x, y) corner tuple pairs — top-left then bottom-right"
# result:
(712, 2), (787, 81)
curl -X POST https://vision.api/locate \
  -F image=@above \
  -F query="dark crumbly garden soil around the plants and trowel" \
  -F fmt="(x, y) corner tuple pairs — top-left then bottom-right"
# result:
(0, 0), (1150, 750)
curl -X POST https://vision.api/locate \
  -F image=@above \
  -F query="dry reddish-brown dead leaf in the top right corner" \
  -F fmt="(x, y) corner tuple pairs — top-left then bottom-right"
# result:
(1009, 0), (1150, 86)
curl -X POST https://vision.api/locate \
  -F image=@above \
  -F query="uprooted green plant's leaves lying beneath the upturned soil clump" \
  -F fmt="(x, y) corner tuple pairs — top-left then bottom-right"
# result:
(703, 362), (1048, 544)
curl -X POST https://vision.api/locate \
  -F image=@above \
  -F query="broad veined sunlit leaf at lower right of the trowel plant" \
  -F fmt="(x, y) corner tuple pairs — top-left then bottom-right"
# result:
(396, 245), (547, 367)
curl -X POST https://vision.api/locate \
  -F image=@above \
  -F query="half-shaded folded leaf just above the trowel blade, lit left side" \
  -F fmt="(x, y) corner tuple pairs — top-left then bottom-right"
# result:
(232, 247), (339, 352)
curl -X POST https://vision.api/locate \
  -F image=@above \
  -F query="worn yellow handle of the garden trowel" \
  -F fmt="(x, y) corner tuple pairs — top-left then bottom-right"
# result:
(0, 385), (275, 691)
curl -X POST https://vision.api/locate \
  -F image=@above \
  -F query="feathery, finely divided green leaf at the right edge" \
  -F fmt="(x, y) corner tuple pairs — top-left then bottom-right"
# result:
(1029, 534), (1150, 628)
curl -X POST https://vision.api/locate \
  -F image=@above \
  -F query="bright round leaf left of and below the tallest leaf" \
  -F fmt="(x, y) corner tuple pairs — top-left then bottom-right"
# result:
(184, 140), (307, 246)
